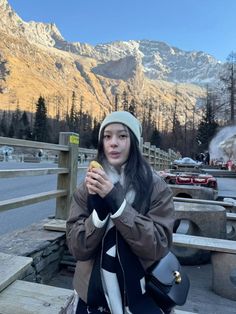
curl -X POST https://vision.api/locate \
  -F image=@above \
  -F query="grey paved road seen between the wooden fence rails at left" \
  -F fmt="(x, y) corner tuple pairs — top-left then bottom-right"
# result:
(0, 162), (84, 235)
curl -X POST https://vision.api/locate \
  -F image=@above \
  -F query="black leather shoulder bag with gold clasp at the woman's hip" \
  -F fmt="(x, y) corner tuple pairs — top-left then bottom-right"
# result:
(146, 252), (190, 313)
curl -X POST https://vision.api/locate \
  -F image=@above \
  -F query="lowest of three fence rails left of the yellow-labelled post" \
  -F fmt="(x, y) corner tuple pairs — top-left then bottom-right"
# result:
(0, 190), (67, 212)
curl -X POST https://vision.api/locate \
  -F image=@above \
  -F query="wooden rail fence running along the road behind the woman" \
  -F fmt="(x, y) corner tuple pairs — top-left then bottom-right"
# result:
(0, 132), (177, 219)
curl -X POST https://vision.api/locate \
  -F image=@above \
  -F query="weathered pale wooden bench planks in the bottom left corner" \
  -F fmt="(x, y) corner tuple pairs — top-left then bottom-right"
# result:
(0, 253), (73, 314)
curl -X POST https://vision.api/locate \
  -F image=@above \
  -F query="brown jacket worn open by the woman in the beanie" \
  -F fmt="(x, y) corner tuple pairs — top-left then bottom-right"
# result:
(67, 173), (174, 302)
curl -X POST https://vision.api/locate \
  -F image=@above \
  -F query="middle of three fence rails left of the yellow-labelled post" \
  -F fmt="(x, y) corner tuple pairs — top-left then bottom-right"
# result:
(0, 168), (69, 178)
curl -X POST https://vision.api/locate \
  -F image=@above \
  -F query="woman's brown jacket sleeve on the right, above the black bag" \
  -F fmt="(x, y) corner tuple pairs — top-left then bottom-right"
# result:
(113, 175), (174, 265)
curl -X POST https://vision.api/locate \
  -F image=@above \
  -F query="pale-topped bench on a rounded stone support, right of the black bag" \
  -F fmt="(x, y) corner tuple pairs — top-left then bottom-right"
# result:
(173, 233), (236, 301)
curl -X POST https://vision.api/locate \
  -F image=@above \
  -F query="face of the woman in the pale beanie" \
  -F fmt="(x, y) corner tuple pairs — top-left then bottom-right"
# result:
(103, 123), (130, 168)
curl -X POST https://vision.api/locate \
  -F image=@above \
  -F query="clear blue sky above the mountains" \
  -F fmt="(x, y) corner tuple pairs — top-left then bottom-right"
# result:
(8, 0), (236, 61)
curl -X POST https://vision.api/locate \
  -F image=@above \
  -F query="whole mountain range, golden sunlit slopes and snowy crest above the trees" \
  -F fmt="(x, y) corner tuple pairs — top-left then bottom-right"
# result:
(0, 0), (218, 121)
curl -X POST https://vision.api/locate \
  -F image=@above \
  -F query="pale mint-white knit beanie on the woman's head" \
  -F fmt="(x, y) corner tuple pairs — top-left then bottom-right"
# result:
(98, 111), (142, 143)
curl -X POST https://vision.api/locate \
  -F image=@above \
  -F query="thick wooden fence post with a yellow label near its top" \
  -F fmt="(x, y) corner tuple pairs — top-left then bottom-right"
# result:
(55, 132), (79, 219)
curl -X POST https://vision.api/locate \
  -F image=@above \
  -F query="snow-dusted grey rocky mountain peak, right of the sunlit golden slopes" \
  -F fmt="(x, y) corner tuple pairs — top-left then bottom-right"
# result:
(86, 40), (222, 84)
